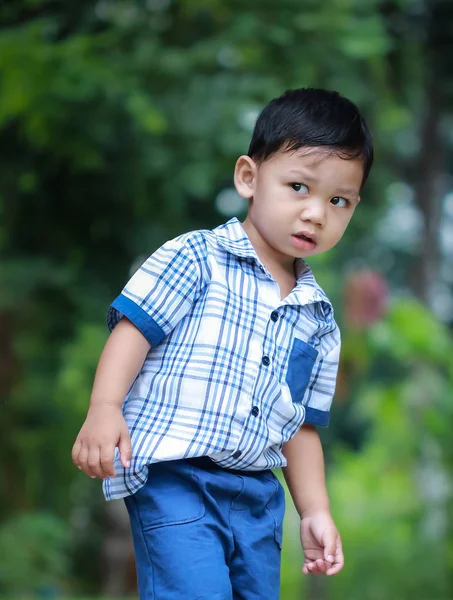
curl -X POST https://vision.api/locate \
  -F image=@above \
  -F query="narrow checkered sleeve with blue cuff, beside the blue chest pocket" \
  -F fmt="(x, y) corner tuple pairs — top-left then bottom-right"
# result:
(303, 343), (341, 427)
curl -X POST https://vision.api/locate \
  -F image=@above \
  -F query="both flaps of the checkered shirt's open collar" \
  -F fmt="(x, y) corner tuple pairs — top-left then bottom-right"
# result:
(214, 217), (331, 310)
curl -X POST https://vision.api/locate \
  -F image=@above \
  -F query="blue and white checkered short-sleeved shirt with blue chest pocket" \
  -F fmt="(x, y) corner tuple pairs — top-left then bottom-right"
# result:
(104, 219), (340, 499)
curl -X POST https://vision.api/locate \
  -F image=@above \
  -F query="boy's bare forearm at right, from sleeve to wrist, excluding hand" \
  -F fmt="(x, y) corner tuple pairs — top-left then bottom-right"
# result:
(283, 425), (330, 518)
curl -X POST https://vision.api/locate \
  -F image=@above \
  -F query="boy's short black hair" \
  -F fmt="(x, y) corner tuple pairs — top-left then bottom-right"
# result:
(248, 88), (374, 185)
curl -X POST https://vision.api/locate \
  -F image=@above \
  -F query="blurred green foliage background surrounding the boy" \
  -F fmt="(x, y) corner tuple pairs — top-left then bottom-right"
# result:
(0, 0), (453, 600)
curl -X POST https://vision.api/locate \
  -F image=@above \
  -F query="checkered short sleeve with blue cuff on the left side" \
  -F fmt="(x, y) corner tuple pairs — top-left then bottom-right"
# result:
(107, 238), (202, 347)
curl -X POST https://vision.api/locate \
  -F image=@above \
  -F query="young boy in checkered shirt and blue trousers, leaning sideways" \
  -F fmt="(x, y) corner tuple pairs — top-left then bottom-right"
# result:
(72, 89), (373, 600)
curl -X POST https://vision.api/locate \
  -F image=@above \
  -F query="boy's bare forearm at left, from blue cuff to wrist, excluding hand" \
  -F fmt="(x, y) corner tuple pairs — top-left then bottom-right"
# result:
(90, 318), (150, 408)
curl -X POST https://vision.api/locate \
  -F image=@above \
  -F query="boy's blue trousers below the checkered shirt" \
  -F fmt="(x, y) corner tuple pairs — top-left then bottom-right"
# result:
(125, 458), (285, 600)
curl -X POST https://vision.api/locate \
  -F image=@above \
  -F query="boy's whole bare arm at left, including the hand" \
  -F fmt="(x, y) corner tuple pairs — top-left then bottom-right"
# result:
(72, 318), (151, 479)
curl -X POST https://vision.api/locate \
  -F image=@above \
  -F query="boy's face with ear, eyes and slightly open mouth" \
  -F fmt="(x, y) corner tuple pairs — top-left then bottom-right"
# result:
(235, 147), (363, 266)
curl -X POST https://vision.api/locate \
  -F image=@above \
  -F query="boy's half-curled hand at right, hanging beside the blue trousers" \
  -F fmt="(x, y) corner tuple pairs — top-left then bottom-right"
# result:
(300, 512), (344, 575)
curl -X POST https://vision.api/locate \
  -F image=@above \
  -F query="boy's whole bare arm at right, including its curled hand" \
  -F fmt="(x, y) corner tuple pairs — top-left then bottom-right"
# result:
(283, 425), (344, 575)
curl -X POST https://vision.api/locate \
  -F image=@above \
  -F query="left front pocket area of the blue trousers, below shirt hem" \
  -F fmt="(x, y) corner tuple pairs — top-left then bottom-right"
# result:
(128, 460), (205, 532)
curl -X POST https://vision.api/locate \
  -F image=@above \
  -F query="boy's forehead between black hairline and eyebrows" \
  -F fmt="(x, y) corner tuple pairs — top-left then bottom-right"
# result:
(262, 147), (364, 192)
